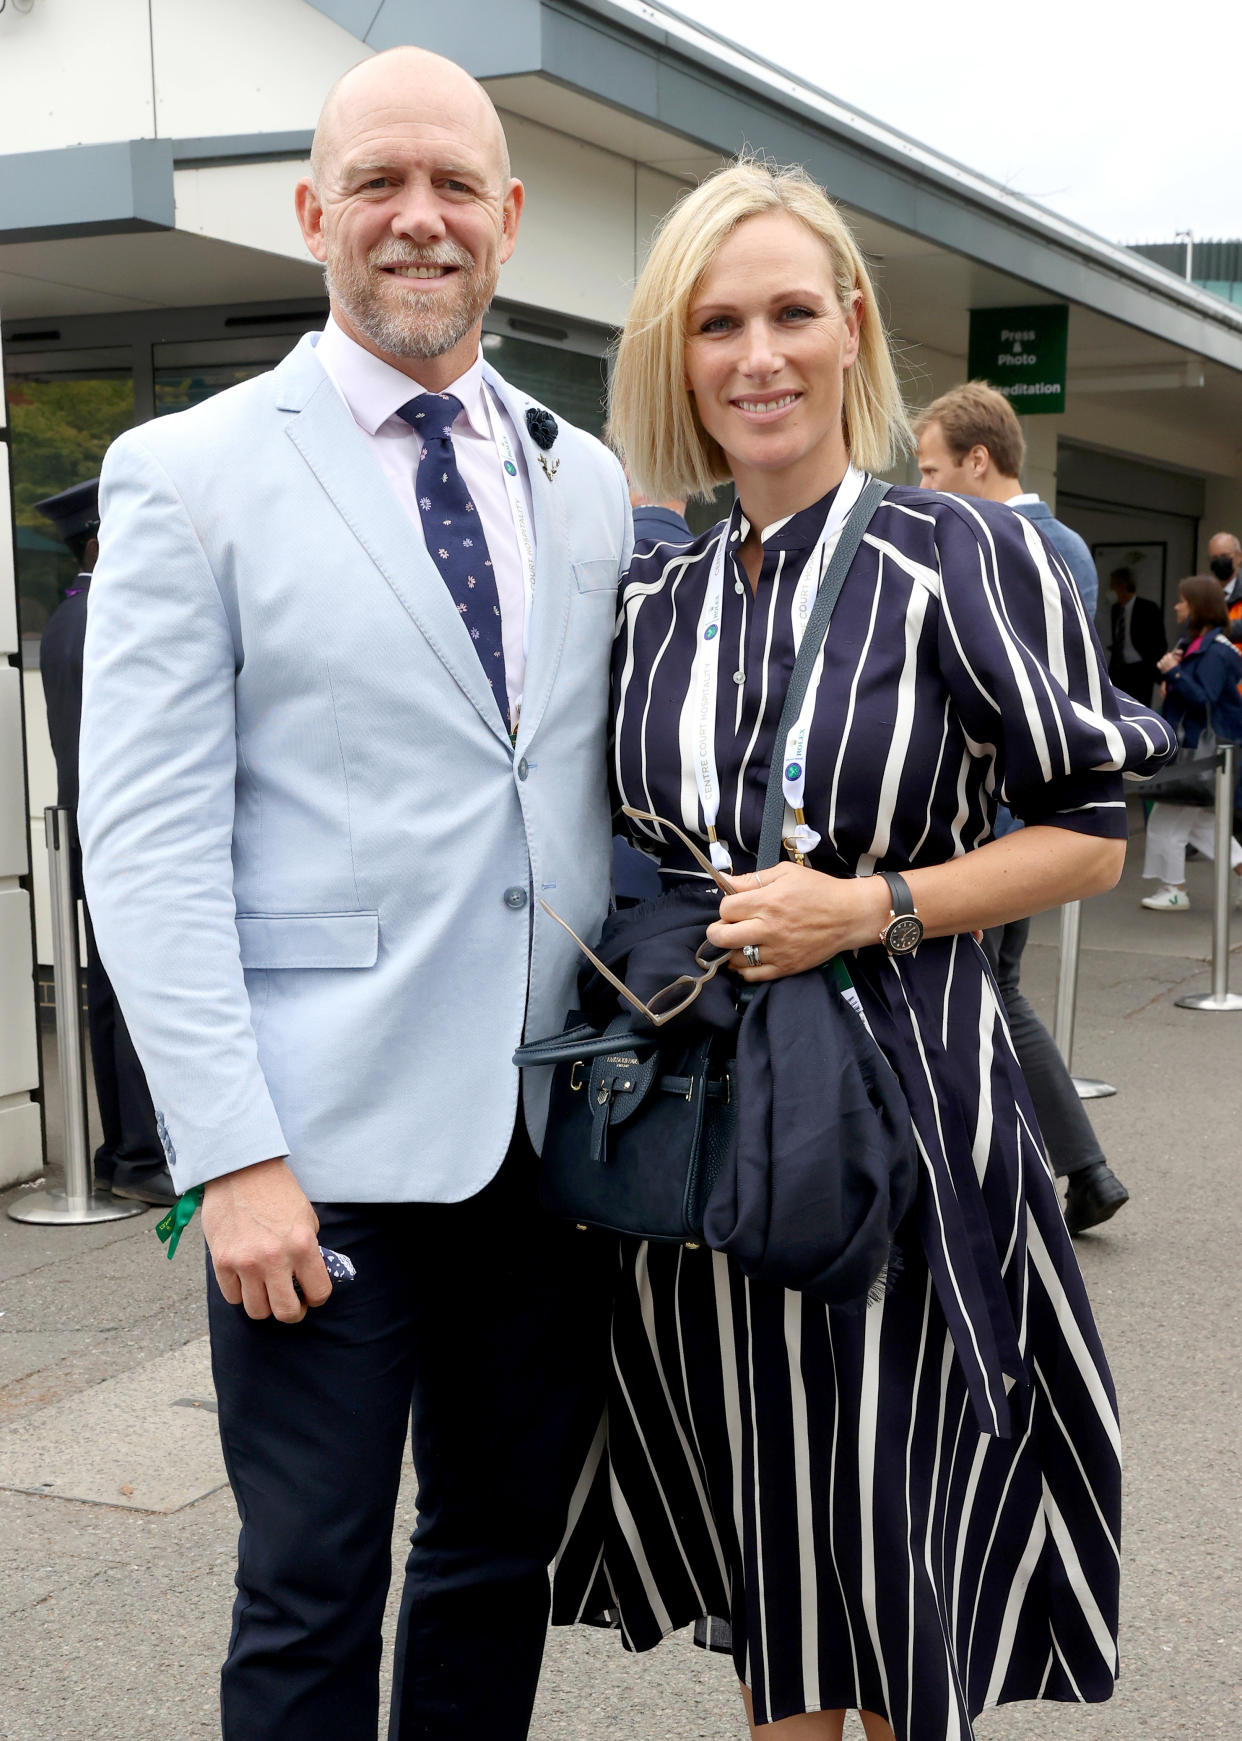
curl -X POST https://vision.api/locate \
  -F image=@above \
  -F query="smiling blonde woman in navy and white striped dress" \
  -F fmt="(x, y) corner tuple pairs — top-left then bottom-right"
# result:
(554, 164), (1171, 1741)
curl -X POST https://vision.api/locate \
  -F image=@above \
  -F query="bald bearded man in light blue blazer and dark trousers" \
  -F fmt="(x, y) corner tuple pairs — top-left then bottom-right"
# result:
(80, 49), (631, 1741)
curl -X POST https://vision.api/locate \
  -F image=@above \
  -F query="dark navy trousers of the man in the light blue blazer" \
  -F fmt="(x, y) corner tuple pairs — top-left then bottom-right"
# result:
(207, 1119), (615, 1741)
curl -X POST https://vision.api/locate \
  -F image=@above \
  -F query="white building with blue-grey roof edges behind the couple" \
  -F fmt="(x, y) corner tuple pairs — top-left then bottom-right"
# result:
(0, 0), (1242, 1184)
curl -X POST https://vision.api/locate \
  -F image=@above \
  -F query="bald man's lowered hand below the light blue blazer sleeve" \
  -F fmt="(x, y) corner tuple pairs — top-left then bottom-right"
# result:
(202, 1160), (333, 1323)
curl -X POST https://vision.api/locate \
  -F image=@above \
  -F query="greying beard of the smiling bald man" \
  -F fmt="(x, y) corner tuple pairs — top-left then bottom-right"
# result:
(324, 239), (498, 360)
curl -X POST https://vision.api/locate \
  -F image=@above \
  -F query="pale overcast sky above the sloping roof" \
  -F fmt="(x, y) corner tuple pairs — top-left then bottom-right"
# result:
(669, 0), (1242, 242)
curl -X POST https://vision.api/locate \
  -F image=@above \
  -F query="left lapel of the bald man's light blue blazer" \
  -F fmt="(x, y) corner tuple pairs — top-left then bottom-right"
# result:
(273, 338), (512, 747)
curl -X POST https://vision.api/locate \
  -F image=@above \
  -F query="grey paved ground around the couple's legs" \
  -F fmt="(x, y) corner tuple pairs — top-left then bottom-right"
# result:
(0, 821), (1242, 1741)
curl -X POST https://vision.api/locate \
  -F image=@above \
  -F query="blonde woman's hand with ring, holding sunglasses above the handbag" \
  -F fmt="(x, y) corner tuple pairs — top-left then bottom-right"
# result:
(707, 860), (890, 985)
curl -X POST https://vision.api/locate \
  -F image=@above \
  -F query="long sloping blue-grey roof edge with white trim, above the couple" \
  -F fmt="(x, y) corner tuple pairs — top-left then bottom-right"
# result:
(308, 0), (1242, 373)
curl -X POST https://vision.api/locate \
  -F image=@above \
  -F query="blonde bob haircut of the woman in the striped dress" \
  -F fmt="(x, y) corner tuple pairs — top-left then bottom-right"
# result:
(610, 158), (915, 501)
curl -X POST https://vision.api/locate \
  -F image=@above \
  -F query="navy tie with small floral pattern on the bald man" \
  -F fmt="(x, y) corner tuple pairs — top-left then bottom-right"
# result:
(397, 393), (509, 719)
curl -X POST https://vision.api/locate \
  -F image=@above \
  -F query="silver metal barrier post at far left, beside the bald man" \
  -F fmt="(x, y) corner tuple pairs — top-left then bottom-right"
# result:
(9, 806), (146, 1227)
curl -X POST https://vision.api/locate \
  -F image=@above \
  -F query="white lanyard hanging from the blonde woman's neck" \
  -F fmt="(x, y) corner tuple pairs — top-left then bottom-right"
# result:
(690, 465), (866, 872)
